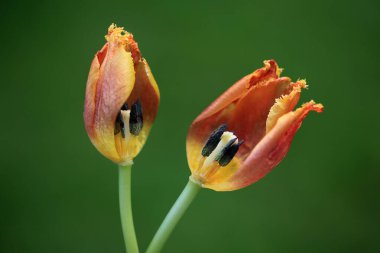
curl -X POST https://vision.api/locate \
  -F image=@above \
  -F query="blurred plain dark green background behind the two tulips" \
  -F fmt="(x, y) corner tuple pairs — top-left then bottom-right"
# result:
(0, 0), (380, 253)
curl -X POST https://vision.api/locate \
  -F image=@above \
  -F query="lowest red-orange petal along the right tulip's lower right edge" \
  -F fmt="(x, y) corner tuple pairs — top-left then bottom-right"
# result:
(207, 101), (323, 191)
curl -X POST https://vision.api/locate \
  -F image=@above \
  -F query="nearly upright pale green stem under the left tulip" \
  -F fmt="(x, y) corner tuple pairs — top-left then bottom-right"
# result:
(119, 165), (139, 253)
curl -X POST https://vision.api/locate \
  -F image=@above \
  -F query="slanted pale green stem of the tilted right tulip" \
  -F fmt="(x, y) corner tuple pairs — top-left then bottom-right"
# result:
(146, 180), (201, 253)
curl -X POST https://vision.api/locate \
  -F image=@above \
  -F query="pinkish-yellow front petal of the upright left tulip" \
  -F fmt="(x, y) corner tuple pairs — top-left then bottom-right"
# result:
(94, 37), (135, 163)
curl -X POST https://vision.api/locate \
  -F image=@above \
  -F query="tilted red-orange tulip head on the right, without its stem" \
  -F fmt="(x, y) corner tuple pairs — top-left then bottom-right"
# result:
(186, 60), (323, 191)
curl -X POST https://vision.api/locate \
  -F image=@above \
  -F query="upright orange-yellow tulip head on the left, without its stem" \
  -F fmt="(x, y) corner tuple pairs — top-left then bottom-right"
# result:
(84, 24), (160, 165)
